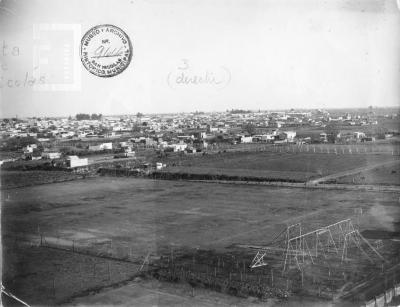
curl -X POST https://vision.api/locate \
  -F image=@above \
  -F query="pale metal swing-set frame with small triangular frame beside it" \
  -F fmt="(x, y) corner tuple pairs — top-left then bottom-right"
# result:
(250, 219), (384, 272)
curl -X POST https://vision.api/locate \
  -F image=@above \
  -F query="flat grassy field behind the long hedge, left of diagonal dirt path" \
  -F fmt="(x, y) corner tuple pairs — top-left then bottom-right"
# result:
(158, 152), (399, 182)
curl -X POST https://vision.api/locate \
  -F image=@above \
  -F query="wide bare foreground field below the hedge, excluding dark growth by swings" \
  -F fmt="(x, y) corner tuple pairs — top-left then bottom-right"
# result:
(2, 177), (400, 305)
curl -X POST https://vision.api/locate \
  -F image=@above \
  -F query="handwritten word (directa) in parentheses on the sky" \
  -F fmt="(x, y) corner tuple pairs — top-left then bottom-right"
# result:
(167, 66), (231, 90)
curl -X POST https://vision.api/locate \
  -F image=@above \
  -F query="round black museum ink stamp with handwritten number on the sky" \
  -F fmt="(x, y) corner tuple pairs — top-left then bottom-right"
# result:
(81, 25), (132, 78)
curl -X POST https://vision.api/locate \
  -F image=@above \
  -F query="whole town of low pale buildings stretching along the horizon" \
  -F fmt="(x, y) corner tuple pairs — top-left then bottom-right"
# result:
(0, 109), (398, 165)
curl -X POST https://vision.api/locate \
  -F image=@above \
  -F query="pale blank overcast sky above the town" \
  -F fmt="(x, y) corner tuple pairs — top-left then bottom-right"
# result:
(0, 0), (400, 117)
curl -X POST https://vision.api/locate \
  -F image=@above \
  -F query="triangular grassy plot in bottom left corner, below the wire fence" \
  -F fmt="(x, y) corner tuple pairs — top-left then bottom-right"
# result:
(3, 244), (139, 306)
